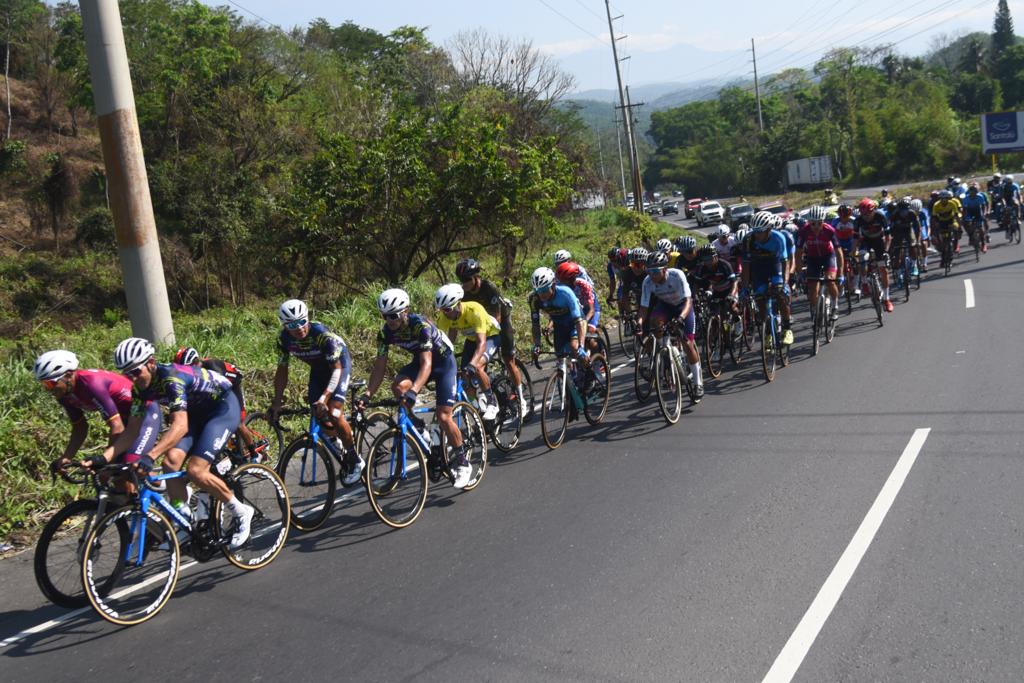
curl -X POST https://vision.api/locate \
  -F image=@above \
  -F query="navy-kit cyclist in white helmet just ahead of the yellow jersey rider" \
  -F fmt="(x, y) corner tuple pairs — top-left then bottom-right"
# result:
(359, 288), (473, 488)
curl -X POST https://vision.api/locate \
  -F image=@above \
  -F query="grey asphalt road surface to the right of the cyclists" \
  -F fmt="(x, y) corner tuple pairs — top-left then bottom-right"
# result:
(0, 233), (1024, 681)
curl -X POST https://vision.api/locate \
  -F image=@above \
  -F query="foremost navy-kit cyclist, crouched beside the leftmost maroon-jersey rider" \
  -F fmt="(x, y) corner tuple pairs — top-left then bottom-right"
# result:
(99, 337), (255, 550)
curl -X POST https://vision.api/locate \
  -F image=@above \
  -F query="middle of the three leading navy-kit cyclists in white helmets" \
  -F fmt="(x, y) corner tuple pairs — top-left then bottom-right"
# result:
(270, 299), (366, 486)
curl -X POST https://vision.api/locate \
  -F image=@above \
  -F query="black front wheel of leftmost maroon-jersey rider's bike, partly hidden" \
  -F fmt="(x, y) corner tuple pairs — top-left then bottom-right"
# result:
(33, 500), (117, 609)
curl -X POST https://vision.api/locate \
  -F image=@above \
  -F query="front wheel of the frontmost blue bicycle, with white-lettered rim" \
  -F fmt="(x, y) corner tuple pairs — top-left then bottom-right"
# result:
(82, 506), (181, 626)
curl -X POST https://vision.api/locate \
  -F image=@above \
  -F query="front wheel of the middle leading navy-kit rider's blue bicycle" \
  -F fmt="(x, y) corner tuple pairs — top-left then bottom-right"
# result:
(275, 434), (338, 531)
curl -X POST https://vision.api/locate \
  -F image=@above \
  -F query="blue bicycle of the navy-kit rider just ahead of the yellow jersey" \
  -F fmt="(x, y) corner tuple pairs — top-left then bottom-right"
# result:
(365, 400), (487, 528)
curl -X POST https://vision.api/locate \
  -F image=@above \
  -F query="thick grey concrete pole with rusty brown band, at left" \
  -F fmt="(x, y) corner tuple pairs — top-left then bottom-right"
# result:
(79, 0), (174, 344)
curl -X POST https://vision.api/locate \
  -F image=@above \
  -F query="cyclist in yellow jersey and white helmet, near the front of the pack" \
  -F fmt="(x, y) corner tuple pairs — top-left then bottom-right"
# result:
(434, 284), (501, 420)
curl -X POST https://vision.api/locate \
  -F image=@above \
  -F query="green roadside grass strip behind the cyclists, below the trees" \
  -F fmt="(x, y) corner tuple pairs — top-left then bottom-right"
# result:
(0, 209), (702, 546)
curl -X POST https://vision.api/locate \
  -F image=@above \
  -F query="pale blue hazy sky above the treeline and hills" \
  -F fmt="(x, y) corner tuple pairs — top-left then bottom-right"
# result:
(204, 0), (1007, 91)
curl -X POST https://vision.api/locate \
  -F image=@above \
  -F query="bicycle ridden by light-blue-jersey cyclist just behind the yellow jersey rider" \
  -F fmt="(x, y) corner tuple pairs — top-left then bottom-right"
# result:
(541, 353), (611, 450)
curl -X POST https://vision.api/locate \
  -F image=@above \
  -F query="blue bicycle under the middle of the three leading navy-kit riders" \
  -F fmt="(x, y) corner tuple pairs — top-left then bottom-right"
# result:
(274, 395), (397, 531)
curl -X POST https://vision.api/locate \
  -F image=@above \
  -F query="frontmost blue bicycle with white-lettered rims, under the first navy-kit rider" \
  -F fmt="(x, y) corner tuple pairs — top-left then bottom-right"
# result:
(82, 458), (289, 626)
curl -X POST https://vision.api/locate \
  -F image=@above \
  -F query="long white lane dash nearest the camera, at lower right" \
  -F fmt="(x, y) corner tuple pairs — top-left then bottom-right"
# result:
(764, 428), (932, 683)
